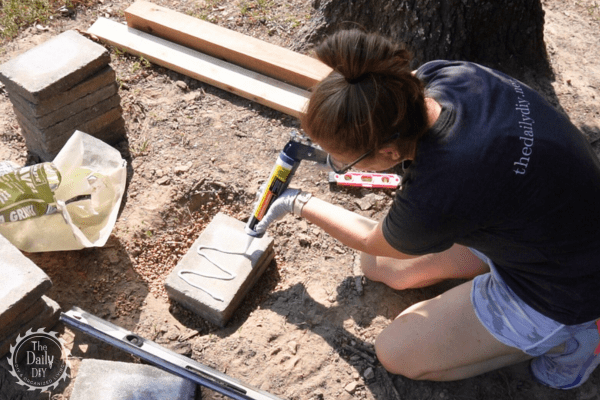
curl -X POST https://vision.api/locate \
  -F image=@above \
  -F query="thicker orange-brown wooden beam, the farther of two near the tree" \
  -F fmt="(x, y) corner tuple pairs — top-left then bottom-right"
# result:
(125, 0), (331, 89)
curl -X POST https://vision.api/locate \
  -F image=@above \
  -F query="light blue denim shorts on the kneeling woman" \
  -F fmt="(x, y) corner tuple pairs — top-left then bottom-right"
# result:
(470, 249), (596, 357)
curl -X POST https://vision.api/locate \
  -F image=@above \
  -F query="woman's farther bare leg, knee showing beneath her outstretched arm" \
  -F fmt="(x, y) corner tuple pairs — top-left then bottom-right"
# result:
(361, 244), (489, 290)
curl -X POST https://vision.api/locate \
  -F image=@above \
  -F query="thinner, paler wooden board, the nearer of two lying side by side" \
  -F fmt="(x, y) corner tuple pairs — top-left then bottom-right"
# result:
(88, 18), (310, 117)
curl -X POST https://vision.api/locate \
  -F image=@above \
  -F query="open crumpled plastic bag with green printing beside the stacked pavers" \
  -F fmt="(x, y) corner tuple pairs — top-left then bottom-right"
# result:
(0, 131), (127, 252)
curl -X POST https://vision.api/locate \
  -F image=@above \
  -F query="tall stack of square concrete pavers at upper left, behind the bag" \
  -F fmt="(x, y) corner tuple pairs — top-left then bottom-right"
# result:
(0, 31), (125, 161)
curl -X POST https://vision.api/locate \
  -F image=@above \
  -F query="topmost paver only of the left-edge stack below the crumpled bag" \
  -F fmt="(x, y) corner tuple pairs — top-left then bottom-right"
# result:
(0, 235), (52, 330)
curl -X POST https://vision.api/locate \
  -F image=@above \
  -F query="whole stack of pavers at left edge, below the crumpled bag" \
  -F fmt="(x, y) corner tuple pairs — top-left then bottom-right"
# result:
(0, 235), (60, 357)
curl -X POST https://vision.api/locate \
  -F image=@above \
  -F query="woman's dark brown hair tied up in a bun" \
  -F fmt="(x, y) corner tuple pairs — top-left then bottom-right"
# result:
(301, 29), (427, 156)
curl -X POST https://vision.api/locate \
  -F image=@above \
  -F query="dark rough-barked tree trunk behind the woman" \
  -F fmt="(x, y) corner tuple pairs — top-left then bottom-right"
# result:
(297, 0), (549, 73)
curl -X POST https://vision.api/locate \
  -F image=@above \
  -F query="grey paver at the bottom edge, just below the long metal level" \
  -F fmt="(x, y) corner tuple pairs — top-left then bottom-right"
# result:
(69, 359), (196, 400)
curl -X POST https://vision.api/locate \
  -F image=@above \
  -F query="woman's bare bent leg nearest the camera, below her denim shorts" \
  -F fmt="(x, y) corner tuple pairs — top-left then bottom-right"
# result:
(375, 281), (531, 381)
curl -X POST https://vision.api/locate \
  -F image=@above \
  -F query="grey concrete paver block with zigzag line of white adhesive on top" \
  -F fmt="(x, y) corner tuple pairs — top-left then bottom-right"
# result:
(164, 213), (274, 327)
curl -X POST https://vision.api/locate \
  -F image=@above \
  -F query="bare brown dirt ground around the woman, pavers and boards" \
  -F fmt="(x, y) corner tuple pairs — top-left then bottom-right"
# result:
(0, 0), (600, 400)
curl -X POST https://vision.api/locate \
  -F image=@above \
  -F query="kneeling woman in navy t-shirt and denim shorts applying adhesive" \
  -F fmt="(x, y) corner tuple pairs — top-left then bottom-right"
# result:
(257, 30), (600, 389)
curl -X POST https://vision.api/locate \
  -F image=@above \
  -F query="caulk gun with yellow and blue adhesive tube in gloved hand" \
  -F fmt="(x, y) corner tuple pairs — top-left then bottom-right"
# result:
(246, 131), (327, 237)
